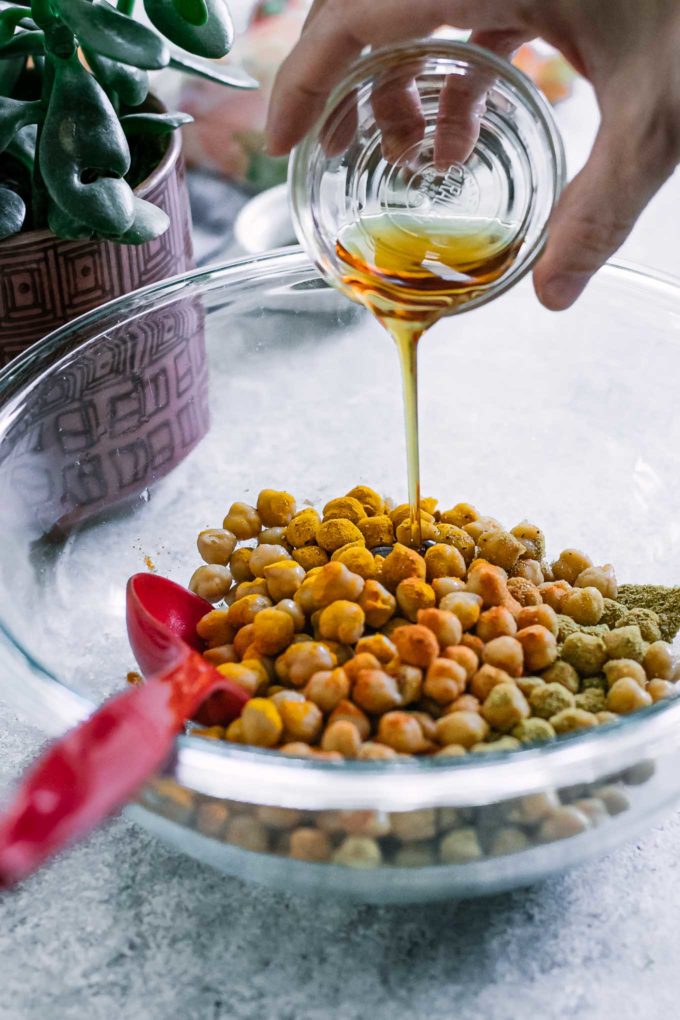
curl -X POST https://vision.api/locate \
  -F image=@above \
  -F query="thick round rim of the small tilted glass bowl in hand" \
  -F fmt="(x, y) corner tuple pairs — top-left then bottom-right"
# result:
(287, 36), (567, 315)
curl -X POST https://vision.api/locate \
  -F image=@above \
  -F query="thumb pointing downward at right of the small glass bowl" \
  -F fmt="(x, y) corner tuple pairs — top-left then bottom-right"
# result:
(533, 122), (675, 311)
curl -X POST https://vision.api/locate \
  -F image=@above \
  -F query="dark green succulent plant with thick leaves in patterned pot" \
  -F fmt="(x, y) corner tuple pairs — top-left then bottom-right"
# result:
(0, 0), (256, 244)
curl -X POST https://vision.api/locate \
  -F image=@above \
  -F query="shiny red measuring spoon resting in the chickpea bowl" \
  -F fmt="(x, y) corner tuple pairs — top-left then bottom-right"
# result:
(0, 574), (249, 886)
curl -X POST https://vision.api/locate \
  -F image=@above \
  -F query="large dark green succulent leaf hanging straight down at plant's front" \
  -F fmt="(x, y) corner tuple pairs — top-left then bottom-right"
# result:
(40, 57), (135, 236)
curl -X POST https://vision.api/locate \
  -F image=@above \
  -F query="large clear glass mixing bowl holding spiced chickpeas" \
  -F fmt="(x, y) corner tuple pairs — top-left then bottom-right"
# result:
(0, 251), (680, 902)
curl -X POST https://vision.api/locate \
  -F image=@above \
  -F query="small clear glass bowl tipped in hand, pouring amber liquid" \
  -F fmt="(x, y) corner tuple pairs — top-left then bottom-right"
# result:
(289, 38), (565, 311)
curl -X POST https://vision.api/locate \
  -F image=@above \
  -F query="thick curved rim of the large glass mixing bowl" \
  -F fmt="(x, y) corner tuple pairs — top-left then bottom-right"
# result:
(0, 248), (680, 811)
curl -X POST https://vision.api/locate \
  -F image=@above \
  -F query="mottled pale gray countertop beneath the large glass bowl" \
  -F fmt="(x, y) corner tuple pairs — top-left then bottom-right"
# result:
(0, 83), (680, 1020)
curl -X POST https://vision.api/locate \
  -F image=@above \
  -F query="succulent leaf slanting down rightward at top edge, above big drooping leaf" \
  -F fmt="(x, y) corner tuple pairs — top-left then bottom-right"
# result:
(59, 0), (170, 70)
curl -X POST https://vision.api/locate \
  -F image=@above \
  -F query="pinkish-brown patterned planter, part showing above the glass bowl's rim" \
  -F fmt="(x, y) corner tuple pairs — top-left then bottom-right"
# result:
(0, 117), (193, 365)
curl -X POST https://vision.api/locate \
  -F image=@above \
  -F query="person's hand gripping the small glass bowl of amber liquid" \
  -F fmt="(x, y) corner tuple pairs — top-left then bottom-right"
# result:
(267, 0), (680, 310)
